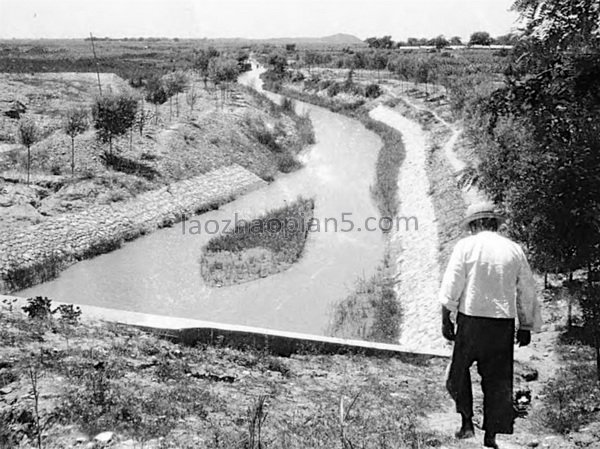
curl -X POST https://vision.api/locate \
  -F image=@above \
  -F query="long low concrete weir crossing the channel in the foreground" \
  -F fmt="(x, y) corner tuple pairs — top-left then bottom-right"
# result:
(0, 295), (448, 361)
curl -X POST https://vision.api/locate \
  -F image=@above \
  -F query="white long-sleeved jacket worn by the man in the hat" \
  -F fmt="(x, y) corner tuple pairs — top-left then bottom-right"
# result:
(439, 231), (542, 332)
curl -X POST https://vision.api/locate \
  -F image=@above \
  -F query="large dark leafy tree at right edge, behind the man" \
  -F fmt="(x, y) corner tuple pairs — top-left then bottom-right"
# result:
(473, 0), (600, 280)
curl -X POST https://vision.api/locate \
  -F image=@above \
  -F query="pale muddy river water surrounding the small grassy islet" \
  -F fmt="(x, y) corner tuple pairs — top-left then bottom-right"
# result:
(18, 65), (384, 334)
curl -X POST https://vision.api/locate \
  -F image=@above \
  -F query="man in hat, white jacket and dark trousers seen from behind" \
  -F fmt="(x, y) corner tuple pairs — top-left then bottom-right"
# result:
(439, 203), (541, 448)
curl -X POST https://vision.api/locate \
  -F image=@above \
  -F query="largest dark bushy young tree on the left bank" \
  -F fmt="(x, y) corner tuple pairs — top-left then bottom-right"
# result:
(92, 94), (137, 156)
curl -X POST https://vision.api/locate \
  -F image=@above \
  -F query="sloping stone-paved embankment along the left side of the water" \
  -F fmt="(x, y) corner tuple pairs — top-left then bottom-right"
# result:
(0, 165), (266, 293)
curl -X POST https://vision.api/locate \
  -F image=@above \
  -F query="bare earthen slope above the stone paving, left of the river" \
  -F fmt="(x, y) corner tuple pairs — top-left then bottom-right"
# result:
(0, 73), (308, 229)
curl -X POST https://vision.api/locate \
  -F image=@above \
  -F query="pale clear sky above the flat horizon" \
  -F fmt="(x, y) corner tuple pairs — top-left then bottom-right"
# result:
(0, 0), (517, 40)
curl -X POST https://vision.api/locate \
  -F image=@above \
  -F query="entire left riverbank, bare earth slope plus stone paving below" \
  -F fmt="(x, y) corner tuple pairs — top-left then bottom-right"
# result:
(0, 69), (314, 292)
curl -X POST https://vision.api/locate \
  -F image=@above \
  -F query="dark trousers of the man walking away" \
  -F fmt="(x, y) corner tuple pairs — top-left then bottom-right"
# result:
(446, 313), (515, 434)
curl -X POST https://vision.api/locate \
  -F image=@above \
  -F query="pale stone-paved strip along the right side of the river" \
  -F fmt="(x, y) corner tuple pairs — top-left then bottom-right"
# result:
(370, 106), (449, 354)
